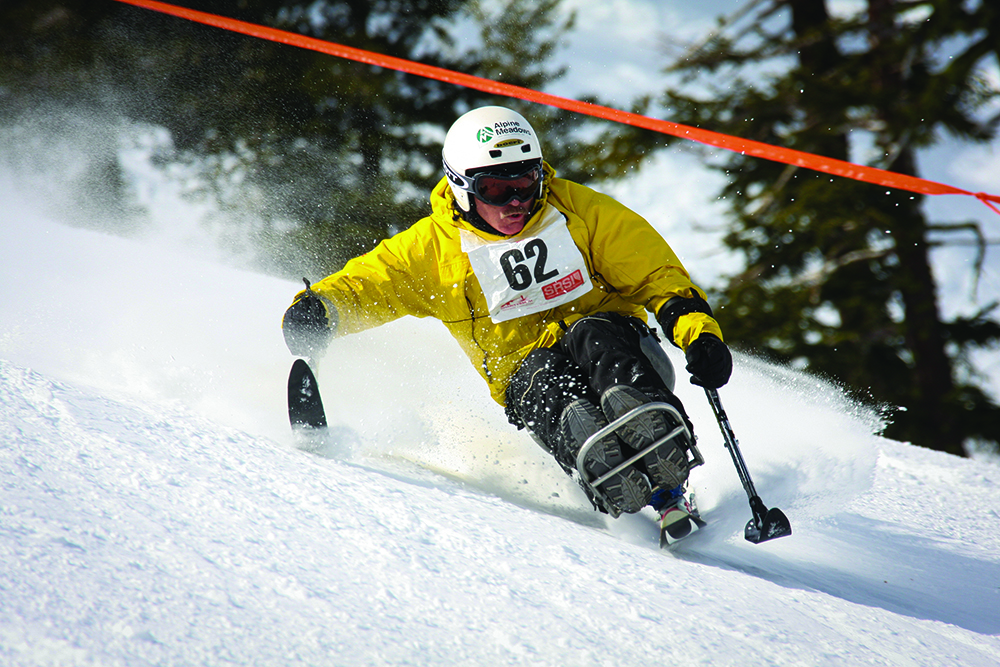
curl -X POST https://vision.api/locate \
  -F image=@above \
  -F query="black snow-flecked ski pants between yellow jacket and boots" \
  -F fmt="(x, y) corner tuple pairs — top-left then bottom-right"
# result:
(506, 313), (686, 468)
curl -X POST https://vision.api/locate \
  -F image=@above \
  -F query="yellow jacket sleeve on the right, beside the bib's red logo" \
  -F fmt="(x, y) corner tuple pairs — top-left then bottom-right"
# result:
(574, 183), (722, 350)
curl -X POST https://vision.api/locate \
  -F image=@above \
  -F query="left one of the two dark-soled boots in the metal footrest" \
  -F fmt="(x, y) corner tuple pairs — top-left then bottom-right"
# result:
(559, 399), (653, 518)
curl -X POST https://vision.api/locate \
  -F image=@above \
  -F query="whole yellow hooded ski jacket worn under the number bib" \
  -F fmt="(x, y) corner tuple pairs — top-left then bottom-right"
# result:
(302, 166), (722, 405)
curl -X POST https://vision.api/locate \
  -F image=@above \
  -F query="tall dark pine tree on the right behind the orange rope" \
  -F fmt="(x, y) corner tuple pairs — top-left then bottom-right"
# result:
(648, 0), (1000, 455)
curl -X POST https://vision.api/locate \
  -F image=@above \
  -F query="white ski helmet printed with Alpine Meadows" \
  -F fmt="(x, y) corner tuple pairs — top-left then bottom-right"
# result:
(442, 107), (542, 212)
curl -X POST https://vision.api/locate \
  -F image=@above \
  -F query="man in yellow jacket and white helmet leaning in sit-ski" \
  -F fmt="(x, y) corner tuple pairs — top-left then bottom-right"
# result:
(282, 106), (732, 522)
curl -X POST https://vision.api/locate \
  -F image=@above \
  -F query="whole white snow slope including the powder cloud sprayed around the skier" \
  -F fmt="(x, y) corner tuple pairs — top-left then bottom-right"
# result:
(0, 170), (1000, 667)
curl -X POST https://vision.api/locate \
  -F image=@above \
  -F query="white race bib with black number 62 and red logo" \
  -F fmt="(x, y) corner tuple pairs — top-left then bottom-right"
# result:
(461, 206), (593, 322)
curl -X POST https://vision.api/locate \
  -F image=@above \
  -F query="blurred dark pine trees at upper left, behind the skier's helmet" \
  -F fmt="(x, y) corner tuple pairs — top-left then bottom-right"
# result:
(0, 0), (576, 275)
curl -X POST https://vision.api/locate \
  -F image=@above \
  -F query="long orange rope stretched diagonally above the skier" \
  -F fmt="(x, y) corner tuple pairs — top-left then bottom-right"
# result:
(111, 0), (1000, 214)
